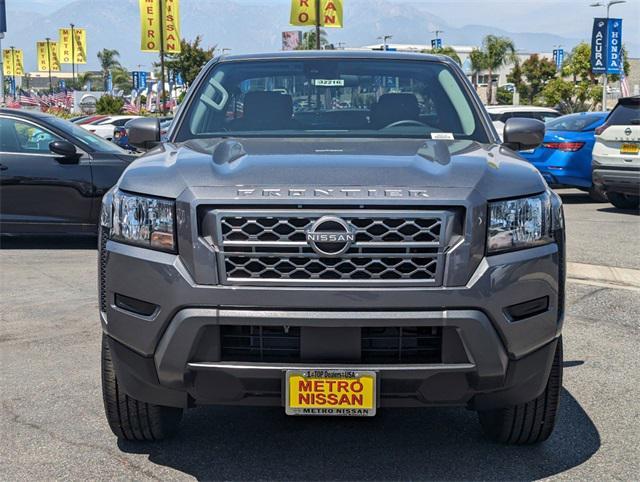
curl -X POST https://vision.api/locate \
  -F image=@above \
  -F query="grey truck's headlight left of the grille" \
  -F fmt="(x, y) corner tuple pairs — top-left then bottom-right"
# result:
(111, 191), (176, 251)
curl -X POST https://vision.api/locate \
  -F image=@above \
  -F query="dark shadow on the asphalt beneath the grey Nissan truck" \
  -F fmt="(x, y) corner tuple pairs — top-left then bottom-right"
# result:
(119, 390), (600, 480)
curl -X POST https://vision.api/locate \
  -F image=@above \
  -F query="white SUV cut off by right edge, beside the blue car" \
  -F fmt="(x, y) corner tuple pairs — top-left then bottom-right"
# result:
(591, 95), (640, 210)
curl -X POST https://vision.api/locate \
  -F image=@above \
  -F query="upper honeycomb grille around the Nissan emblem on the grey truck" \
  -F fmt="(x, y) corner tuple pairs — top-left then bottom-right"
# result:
(211, 210), (452, 285)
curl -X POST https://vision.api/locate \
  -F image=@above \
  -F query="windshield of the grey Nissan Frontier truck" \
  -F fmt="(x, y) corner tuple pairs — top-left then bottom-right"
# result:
(176, 59), (488, 143)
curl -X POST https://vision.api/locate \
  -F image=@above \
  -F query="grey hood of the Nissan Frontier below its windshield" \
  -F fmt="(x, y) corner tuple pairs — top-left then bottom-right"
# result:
(119, 138), (546, 199)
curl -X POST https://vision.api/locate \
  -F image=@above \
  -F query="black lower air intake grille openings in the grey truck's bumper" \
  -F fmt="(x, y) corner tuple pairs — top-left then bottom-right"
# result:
(220, 325), (442, 365)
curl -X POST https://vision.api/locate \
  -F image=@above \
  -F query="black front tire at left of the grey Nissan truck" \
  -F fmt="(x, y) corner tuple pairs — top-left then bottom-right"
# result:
(102, 335), (182, 441)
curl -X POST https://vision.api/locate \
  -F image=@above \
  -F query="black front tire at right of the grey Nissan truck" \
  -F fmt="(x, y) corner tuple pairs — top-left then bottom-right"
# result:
(478, 338), (562, 445)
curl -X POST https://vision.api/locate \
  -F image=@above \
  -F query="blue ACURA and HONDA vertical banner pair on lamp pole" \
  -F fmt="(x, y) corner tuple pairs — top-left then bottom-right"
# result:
(591, 18), (623, 74)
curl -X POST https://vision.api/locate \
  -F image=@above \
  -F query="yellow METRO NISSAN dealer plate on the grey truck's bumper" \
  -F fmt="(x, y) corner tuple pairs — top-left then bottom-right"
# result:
(285, 370), (376, 417)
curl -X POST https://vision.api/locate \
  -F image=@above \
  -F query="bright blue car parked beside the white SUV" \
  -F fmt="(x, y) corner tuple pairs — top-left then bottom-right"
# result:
(520, 112), (607, 199)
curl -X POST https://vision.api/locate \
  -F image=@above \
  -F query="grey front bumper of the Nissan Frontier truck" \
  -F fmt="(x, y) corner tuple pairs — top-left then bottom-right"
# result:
(101, 241), (564, 408)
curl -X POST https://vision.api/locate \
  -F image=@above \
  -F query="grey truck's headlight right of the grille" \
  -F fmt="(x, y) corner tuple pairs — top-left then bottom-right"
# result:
(487, 192), (553, 254)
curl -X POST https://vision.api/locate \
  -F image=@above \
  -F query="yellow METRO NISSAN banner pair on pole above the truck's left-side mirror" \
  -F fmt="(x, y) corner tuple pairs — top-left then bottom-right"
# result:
(139, 0), (180, 53)
